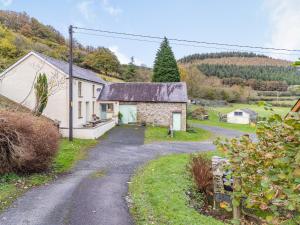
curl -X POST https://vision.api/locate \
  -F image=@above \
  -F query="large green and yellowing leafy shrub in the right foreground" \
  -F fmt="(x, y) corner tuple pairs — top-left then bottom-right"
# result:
(216, 114), (300, 224)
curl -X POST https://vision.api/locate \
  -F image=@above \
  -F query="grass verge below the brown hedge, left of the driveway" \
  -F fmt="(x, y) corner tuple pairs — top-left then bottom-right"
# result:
(0, 139), (97, 211)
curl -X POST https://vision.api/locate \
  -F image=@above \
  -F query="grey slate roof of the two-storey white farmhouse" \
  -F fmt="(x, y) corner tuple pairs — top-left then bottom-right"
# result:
(33, 52), (106, 84)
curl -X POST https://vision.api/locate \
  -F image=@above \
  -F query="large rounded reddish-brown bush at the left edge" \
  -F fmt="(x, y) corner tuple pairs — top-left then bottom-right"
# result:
(0, 111), (59, 174)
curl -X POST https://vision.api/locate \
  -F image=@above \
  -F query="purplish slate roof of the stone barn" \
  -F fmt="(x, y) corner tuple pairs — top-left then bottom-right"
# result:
(98, 82), (188, 103)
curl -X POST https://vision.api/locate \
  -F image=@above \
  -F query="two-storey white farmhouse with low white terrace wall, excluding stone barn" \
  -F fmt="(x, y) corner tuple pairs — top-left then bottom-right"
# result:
(0, 52), (117, 138)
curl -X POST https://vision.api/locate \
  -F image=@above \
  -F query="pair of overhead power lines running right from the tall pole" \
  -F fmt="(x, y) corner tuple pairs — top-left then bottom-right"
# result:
(74, 32), (299, 56)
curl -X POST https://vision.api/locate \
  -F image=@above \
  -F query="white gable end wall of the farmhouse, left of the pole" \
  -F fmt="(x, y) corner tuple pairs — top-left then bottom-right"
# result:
(0, 55), (68, 125)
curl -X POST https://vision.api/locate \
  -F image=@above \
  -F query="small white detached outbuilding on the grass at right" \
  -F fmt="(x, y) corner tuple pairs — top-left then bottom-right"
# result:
(227, 109), (257, 124)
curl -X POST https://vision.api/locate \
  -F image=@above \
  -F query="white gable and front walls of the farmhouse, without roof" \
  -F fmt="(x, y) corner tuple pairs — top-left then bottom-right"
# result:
(0, 54), (103, 132)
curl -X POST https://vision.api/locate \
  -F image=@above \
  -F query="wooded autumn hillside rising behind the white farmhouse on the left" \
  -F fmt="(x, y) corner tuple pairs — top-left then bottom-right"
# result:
(0, 10), (151, 81)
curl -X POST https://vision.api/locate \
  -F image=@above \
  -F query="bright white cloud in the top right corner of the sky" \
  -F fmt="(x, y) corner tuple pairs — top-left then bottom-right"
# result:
(264, 0), (300, 60)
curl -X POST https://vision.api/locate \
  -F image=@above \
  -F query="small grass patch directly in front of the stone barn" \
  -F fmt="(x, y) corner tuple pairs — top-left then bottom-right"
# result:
(145, 126), (212, 143)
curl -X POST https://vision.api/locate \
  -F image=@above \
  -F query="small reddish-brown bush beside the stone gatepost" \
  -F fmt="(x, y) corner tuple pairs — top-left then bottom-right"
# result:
(188, 155), (213, 196)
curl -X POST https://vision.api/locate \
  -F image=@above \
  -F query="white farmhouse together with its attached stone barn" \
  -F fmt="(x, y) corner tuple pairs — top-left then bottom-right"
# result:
(0, 52), (188, 139)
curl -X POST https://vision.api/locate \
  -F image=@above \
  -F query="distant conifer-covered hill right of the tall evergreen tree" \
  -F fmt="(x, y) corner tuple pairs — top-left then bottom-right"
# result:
(178, 52), (300, 91)
